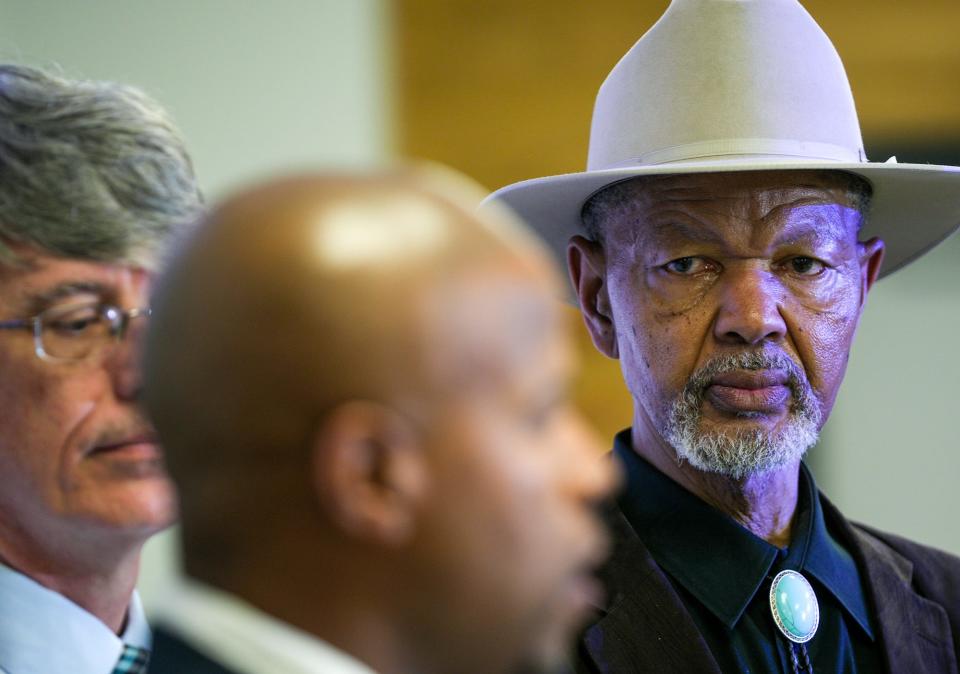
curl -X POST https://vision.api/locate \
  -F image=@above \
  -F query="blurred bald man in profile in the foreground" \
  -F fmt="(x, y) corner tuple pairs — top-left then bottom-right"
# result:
(146, 172), (614, 674)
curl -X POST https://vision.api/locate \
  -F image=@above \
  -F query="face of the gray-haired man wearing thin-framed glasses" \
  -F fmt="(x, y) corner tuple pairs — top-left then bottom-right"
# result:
(0, 244), (173, 572)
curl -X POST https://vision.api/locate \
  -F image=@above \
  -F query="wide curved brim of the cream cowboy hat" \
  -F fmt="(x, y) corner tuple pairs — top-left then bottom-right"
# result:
(484, 160), (960, 277)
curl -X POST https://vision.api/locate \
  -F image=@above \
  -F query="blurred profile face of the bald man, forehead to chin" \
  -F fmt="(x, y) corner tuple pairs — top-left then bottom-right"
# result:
(423, 268), (615, 671)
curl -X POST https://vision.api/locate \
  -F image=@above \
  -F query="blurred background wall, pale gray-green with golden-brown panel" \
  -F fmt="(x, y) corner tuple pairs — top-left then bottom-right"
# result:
(0, 0), (960, 600)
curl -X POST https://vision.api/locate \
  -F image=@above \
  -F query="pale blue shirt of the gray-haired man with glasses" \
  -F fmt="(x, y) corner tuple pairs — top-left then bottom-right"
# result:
(0, 564), (150, 674)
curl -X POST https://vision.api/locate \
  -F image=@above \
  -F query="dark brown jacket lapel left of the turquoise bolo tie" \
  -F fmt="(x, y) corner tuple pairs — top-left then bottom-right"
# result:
(583, 510), (720, 674)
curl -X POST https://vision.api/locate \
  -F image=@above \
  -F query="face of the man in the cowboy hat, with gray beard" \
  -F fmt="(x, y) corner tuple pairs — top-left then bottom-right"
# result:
(572, 172), (882, 478)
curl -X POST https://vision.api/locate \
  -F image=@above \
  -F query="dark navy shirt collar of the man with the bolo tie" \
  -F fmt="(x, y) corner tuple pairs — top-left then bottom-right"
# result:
(613, 430), (873, 639)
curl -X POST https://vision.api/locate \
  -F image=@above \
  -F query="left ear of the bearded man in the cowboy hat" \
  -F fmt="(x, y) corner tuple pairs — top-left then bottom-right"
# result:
(567, 235), (620, 358)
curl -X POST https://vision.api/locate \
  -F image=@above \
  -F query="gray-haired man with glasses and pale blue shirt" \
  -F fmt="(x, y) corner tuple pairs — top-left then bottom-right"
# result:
(0, 65), (201, 674)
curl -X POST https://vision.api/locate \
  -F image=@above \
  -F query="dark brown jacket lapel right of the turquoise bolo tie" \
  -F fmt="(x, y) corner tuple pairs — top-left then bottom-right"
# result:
(821, 495), (957, 674)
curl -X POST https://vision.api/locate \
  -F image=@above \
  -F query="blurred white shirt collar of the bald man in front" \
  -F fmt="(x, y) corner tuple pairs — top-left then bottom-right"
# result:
(156, 579), (376, 674)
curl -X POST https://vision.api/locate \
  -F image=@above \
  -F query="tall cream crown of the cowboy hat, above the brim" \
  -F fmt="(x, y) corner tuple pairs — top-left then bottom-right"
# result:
(587, 0), (866, 170)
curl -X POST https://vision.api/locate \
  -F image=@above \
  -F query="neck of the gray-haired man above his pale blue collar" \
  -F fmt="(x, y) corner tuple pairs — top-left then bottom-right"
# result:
(0, 545), (140, 634)
